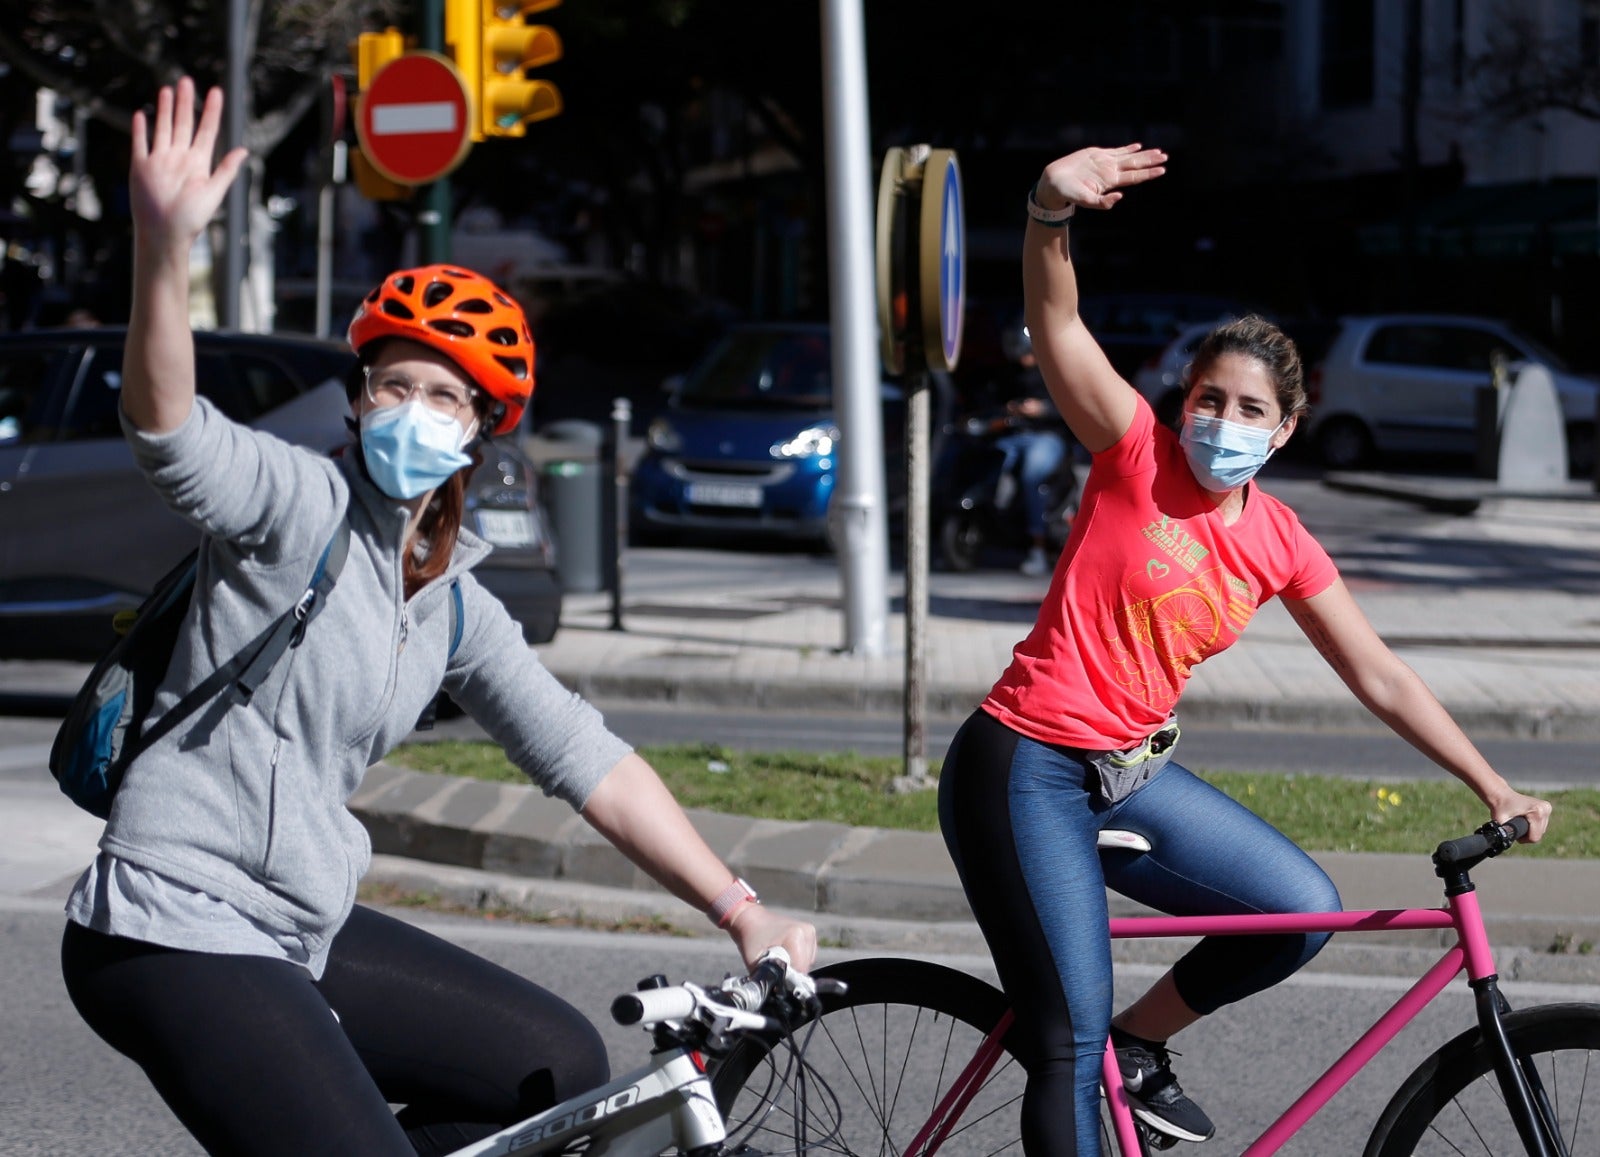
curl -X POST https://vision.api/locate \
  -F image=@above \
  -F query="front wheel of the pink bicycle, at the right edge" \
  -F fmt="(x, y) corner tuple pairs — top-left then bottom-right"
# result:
(1366, 1005), (1600, 1157)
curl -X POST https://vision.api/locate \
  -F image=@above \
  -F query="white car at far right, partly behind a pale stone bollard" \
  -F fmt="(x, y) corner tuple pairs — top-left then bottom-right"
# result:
(1307, 314), (1600, 477)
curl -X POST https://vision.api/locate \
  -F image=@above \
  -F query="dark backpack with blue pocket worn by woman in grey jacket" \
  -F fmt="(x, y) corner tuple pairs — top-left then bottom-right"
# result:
(50, 518), (350, 819)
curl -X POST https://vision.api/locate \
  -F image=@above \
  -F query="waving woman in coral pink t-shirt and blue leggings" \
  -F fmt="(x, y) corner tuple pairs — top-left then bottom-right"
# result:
(939, 144), (1550, 1157)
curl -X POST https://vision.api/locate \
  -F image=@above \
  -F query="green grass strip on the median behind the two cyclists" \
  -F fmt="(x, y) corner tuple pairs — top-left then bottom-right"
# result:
(389, 741), (1600, 859)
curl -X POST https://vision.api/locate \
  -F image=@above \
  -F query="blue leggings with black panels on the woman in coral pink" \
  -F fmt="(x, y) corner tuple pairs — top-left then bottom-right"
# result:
(939, 711), (1339, 1157)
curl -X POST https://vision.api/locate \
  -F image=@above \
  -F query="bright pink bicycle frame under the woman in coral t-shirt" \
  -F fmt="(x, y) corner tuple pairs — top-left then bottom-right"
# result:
(906, 891), (1494, 1157)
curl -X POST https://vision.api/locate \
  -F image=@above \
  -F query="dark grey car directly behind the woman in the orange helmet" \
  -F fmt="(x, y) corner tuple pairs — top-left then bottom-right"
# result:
(0, 326), (562, 661)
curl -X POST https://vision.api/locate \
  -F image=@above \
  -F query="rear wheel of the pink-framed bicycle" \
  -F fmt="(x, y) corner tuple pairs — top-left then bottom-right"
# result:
(712, 959), (1026, 1157)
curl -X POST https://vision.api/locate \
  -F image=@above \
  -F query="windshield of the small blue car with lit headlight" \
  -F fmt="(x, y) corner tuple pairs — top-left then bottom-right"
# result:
(677, 330), (834, 410)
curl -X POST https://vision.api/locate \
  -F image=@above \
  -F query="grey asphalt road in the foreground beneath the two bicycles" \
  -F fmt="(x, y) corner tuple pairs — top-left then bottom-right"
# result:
(0, 899), (1597, 1157)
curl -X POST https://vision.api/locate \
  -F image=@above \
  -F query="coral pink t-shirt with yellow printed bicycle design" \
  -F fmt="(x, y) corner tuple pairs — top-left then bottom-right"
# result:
(982, 398), (1339, 751)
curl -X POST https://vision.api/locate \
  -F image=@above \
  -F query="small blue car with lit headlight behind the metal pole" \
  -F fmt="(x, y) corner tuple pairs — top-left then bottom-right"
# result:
(632, 323), (906, 542)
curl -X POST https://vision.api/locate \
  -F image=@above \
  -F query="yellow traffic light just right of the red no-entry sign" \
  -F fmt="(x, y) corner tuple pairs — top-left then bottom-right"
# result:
(445, 0), (562, 141)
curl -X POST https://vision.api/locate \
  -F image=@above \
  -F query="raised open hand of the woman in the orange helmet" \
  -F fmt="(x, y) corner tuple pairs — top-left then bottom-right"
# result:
(128, 77), (248, 251)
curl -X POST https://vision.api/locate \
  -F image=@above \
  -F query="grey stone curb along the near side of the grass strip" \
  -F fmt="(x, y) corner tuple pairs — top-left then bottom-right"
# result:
(350, 763), (1600, 984)
